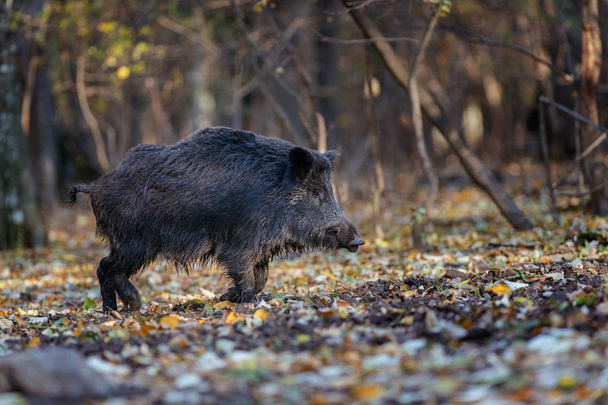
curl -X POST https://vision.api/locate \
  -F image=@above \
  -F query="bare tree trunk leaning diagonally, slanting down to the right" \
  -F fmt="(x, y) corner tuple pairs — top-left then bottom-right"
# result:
(342, 0), (532, 230)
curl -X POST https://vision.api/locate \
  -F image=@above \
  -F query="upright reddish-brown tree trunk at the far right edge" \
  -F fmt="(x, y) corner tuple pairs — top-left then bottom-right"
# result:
(581, 0), (608, 215)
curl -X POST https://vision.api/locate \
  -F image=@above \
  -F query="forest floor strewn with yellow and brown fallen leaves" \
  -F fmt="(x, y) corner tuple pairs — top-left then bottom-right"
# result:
(0, 178), (608, 404)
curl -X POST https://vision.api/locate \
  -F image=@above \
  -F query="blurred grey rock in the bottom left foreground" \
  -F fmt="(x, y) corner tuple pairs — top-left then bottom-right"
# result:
(0, 348), (113, 399)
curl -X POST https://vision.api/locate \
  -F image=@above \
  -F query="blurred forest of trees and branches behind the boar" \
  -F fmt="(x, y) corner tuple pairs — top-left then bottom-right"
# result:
(0, 0), (608, 249)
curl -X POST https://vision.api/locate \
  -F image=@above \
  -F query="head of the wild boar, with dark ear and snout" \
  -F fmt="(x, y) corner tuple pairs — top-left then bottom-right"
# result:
(285, 147), (365, 252)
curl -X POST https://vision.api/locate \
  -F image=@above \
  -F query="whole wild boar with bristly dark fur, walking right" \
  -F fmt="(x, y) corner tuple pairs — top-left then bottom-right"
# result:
(68, 127), (363, 311)
